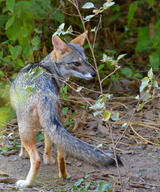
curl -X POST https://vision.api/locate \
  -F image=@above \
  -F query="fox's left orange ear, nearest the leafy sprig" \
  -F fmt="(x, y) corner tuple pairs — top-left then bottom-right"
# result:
(52, 35), (71, 55)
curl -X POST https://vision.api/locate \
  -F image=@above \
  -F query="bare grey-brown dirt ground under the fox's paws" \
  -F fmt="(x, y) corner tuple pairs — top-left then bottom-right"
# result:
(0, 142), (160, 192)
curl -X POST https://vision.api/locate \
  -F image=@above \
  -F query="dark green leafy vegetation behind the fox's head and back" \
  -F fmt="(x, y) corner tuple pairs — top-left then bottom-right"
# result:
(0, 0), (160, 135)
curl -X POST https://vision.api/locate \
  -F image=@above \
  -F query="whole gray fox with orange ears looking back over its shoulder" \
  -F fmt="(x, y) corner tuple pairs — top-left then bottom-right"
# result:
(10, 32), (122, 188)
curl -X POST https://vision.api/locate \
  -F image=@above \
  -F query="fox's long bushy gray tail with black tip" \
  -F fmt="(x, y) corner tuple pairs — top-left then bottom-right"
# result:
(39, 99), (122, 167)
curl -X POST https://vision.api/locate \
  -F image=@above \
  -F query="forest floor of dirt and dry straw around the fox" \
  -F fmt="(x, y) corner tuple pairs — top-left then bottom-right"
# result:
(0, 96), (160, 192)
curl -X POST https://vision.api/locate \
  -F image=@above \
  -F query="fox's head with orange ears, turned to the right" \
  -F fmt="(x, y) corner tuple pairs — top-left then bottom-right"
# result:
(52, 32), (96, 80)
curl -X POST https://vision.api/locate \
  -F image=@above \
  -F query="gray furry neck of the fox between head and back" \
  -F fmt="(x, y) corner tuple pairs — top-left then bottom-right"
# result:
(39, 52), (68, 88)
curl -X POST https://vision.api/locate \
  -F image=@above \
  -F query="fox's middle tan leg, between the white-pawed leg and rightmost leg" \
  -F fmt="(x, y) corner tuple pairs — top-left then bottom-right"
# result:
(43, 134), (55, 164)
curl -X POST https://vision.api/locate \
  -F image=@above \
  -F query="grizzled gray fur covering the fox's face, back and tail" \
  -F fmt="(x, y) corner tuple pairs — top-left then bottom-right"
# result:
(10, 44), (120, 172)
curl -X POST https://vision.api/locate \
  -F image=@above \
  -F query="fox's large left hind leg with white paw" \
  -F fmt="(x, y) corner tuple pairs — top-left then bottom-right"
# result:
(16, 121), (41, 188)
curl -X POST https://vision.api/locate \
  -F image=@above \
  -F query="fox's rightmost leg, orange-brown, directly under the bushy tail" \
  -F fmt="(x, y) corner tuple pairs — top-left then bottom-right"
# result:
(57, 147), (67, 179)
